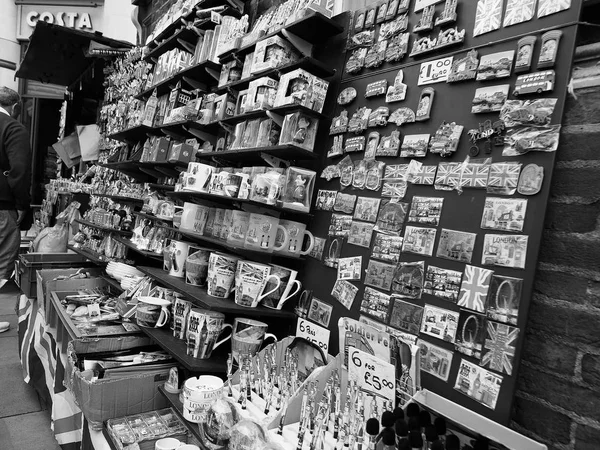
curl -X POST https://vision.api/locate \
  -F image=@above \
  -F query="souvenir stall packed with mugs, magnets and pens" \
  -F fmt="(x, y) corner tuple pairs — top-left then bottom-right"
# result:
(15, 0), (582, 450)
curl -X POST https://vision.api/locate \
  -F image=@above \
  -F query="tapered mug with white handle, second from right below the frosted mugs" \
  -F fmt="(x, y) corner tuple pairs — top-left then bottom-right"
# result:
(235, 261), (281, 308)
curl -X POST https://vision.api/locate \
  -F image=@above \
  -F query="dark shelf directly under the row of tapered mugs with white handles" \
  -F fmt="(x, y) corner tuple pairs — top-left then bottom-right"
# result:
(137, 266), (296, 320)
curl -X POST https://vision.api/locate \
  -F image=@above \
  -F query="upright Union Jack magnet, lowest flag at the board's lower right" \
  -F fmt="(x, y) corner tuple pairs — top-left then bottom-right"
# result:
(481, 321), (519, 375)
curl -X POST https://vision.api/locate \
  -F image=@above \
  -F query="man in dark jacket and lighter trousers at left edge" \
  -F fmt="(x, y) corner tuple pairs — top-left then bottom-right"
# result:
(0, 87), (31, 333)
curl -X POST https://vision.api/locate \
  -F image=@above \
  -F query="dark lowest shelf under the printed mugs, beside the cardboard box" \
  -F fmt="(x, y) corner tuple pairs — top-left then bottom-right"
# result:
(140, 327), (227, 373)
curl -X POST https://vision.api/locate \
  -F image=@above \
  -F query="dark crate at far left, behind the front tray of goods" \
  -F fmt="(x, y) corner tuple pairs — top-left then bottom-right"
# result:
(15, 253), (95, 297)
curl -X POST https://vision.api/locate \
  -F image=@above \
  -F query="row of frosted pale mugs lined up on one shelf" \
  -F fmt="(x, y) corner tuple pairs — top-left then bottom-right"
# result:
(179, 202), (315, 256)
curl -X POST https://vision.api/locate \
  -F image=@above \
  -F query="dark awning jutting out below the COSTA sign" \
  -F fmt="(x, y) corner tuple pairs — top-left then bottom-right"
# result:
(16, 21), (133, 86)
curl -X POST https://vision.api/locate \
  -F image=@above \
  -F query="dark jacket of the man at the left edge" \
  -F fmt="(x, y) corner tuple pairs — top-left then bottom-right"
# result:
(0, 112), (31, 210)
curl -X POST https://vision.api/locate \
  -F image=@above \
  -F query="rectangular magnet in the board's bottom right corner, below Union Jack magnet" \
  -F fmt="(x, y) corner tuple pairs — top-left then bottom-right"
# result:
(454, 359), (502, 410)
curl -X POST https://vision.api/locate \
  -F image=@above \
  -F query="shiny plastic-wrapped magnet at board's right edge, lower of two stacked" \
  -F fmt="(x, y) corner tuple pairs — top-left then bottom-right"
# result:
(502, 125), (560, 156)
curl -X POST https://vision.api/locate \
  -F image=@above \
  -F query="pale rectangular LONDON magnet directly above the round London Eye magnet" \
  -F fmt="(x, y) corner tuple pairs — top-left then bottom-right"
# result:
(481, 234), (528, 269)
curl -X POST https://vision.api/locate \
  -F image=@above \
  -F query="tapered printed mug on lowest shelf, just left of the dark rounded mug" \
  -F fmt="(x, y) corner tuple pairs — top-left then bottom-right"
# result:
(186, 308), (232, 359)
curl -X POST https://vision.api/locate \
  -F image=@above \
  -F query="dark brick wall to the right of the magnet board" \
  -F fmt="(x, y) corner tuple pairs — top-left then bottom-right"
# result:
(512, 53), (600, 450)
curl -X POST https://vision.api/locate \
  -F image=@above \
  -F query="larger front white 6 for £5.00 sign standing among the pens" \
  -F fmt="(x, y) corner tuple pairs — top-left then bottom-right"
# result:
(348, 347), (396, 399)
